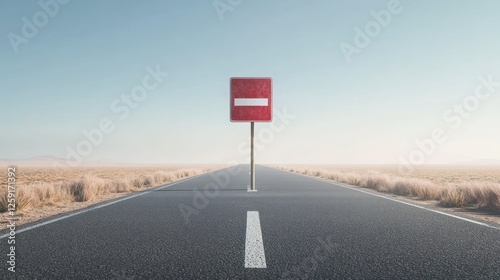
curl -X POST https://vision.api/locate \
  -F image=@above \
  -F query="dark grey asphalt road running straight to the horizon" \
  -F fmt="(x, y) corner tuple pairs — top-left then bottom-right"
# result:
(0, 165), (500, 279)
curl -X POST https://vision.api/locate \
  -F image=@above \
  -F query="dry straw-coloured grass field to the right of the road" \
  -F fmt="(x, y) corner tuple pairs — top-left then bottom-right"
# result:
(280, 166), (500, 211)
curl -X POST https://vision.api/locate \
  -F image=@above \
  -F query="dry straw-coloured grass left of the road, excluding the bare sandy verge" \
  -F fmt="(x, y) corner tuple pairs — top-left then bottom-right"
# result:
(0, 166), (216, 212)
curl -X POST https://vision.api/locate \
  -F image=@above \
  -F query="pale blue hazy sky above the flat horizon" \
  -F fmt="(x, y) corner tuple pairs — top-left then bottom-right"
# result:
(0, 0), (500, 163)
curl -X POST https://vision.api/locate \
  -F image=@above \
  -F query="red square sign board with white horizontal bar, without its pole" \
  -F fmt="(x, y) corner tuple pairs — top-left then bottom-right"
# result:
(230, 78), (272, 122)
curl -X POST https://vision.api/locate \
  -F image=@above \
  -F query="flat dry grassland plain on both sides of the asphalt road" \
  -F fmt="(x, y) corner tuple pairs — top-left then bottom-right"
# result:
(0, 165), (500, 225)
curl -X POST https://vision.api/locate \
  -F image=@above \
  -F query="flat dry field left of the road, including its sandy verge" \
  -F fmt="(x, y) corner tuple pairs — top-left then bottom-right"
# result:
(0, 165), (222, 225)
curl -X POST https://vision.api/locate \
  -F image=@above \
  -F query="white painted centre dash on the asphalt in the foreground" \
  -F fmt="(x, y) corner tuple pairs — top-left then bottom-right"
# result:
(245, 211), (266, 268)
